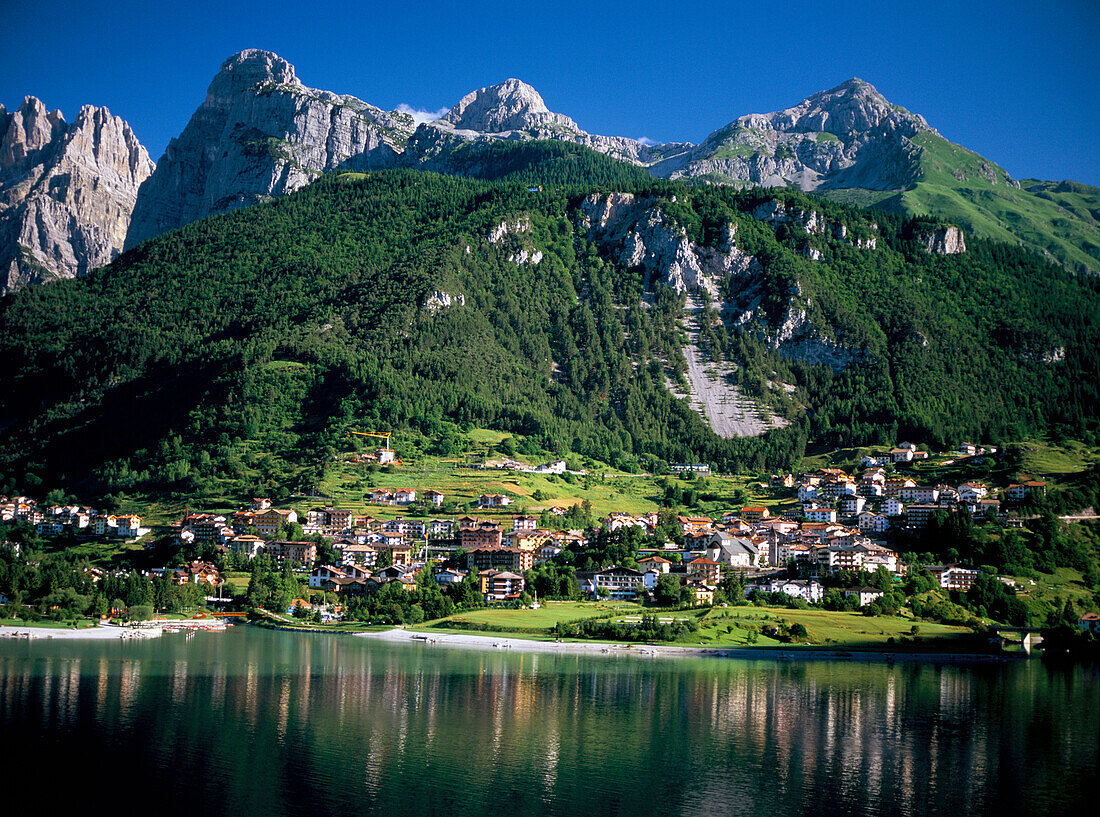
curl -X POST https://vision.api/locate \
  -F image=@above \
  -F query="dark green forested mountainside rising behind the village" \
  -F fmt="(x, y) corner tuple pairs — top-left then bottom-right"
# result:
(0, 148), (1100, 505)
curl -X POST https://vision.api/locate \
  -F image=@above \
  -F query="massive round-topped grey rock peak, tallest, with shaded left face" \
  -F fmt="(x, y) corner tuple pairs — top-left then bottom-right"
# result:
(127, 49), (415, 246)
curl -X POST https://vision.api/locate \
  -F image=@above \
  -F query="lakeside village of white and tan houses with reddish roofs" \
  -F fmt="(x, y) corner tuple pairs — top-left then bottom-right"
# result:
(0, 443), (1073, 637)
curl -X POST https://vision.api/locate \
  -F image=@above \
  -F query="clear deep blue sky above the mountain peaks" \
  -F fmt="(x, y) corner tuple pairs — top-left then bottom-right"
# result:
(0, 0), (1100, 185)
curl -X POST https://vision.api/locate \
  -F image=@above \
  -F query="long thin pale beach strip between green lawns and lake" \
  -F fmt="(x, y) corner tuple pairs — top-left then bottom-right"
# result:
(355, 627), (1023, 663)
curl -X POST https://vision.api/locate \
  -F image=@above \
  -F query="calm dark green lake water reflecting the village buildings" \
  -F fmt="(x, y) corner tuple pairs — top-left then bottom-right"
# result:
(0, 627), (1100, 817)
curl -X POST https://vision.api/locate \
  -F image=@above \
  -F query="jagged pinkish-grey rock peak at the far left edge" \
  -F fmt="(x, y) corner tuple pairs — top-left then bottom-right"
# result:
(0, 97), (154, 294)
